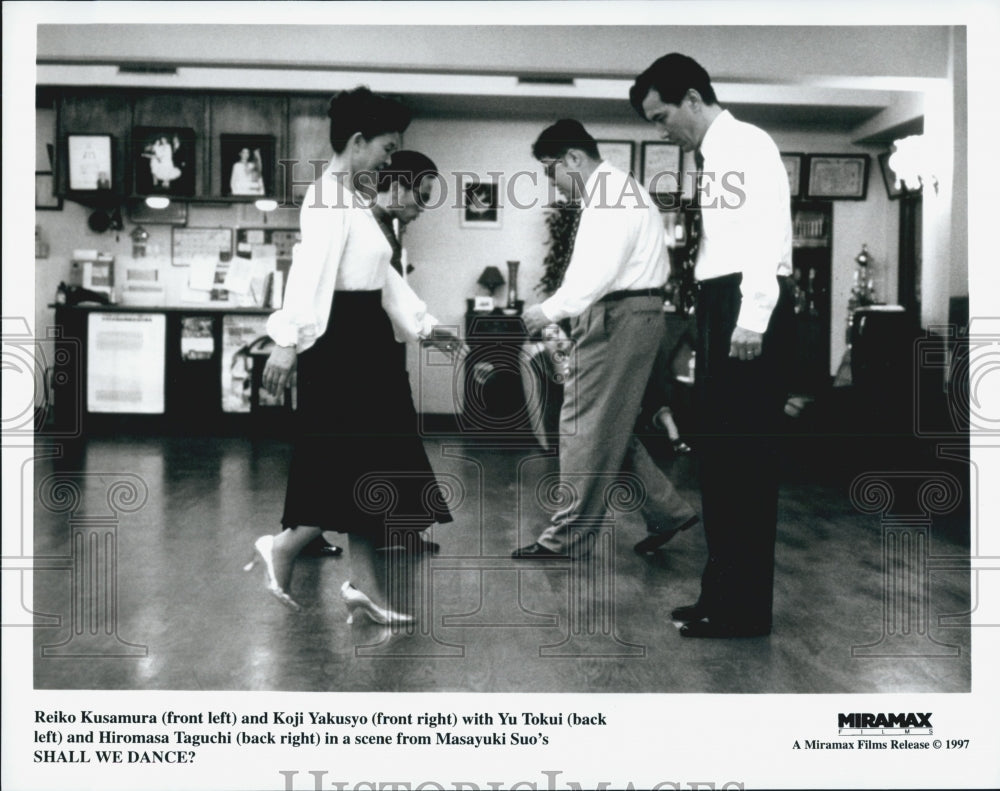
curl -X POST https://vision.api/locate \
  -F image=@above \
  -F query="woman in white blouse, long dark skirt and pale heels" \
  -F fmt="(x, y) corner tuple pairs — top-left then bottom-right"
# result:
(248, 88), (451, 624)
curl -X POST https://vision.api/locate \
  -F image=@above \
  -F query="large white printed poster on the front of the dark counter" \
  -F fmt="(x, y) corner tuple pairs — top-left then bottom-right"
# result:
(87, 313), (167, 415)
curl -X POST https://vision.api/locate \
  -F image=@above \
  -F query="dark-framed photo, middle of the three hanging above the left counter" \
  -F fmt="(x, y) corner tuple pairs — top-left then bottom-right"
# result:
(132, 126), (196, 197)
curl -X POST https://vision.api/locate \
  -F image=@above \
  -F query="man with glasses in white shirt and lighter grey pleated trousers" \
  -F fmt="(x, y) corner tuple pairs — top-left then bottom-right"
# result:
(512, 120), (698, 560)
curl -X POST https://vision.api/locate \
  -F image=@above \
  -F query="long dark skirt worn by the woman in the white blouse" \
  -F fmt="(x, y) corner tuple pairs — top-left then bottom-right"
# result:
(281, 291), (452, 544)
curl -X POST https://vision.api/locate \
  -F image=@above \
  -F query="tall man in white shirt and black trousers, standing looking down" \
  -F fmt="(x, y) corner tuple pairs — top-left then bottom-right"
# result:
(629, 53), (794, 637)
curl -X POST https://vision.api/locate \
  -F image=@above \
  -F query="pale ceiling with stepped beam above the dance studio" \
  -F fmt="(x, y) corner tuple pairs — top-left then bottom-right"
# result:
(37, 25), (952, 143)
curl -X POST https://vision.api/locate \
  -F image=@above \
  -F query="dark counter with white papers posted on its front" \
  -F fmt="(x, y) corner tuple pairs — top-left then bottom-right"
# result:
(53, 305), (292, 436)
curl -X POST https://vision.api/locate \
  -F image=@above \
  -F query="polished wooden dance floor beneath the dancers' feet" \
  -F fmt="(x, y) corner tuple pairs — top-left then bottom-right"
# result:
(33, 420), (971, 693)
